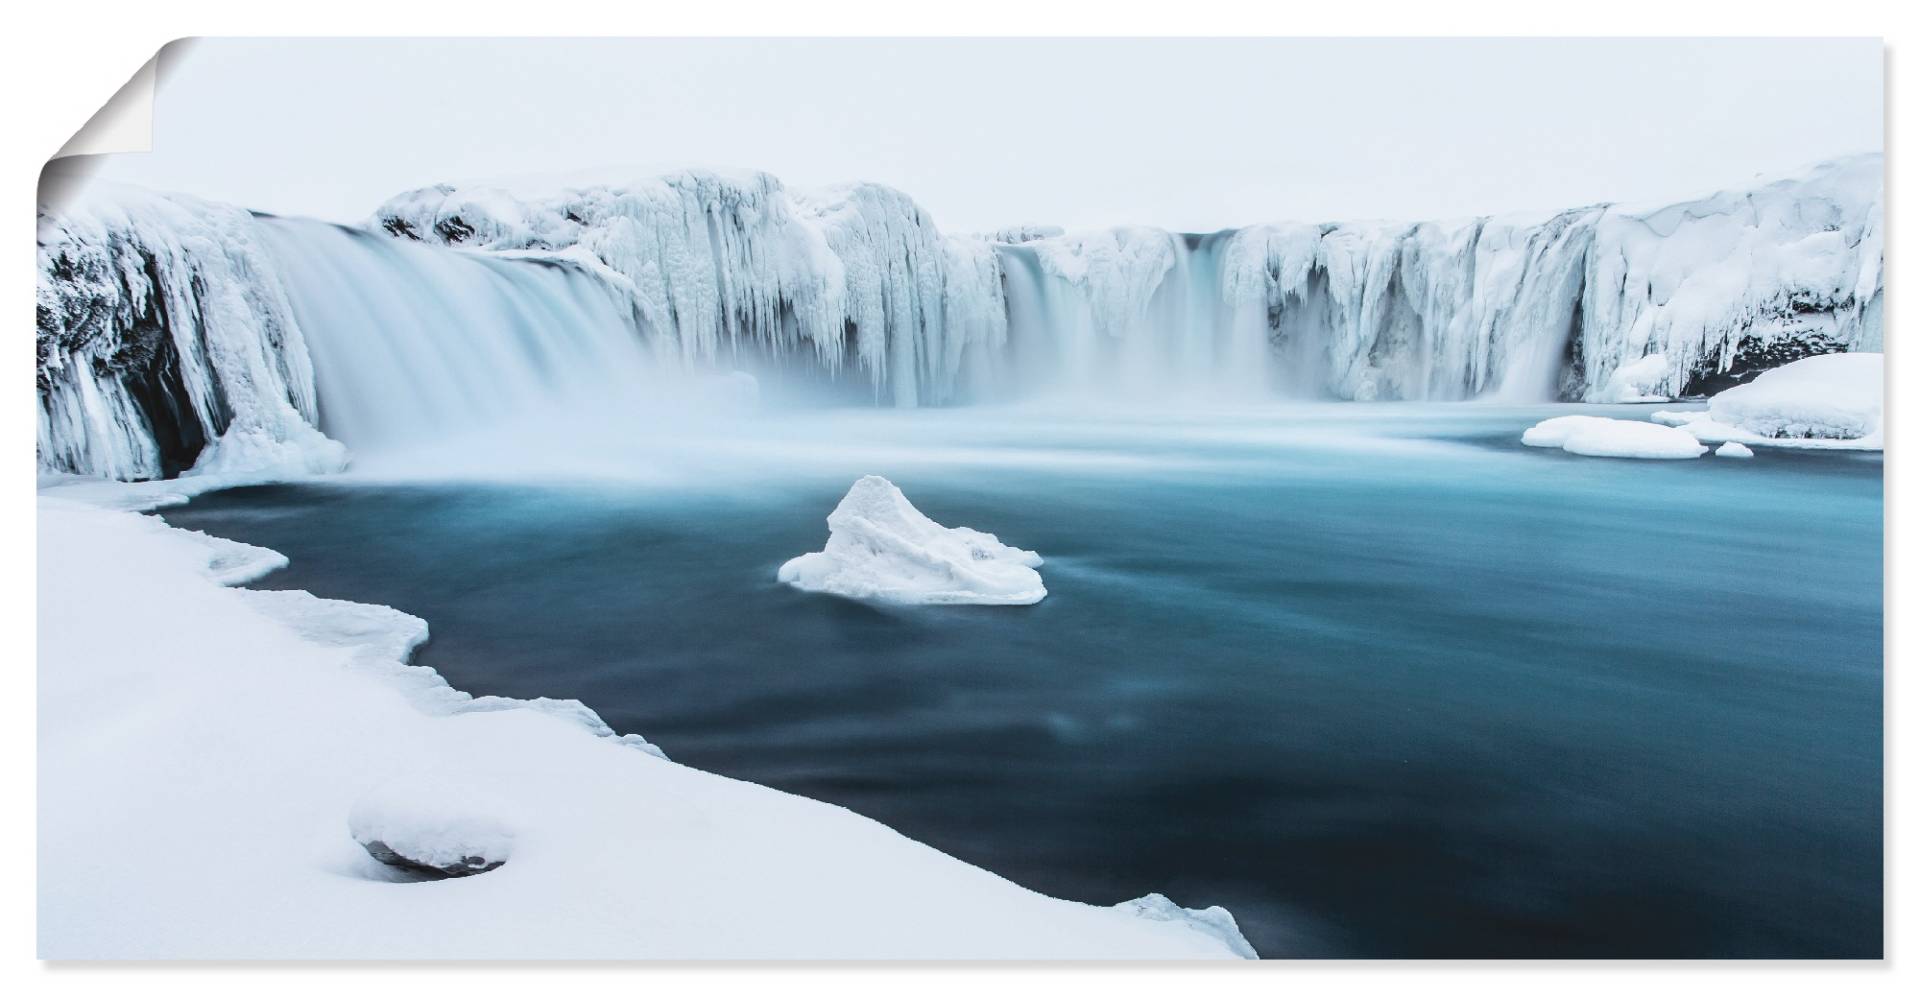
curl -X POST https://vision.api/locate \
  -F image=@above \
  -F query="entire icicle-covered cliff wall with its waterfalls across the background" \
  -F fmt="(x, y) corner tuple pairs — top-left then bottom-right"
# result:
(38, 155), (1884, 478)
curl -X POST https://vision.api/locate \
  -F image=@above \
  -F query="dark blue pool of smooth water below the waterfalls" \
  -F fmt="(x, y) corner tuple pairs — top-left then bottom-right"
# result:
(165, 409), (1882, 958)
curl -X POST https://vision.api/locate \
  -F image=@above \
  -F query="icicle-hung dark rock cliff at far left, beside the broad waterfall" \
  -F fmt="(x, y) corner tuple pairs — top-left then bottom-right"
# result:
(35, 188), (346, 480)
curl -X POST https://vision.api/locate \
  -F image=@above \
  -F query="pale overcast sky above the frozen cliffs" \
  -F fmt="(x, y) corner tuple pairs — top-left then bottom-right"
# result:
(75, 36), (1884, 232)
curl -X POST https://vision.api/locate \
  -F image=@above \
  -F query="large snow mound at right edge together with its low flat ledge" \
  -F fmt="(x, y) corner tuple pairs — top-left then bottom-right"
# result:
(1653, 353), (1885, 451)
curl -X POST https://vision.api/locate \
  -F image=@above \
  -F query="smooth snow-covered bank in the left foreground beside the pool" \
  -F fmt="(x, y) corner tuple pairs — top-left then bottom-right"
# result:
(38, 497), (1250, 960)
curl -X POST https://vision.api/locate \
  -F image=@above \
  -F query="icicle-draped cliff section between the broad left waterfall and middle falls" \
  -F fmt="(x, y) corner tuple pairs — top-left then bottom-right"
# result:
(372, 169), (1006, 407)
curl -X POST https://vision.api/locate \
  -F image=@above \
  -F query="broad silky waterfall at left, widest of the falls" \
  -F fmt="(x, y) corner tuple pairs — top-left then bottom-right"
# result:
(261, 217), (659, 453)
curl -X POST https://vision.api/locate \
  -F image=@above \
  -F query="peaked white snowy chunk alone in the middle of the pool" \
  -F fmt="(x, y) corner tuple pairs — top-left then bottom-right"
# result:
(778, 476), (1046, 605)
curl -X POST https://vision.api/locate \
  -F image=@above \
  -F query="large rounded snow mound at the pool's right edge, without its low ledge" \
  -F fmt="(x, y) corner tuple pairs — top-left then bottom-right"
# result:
(1707, 353), (1885, 439)
